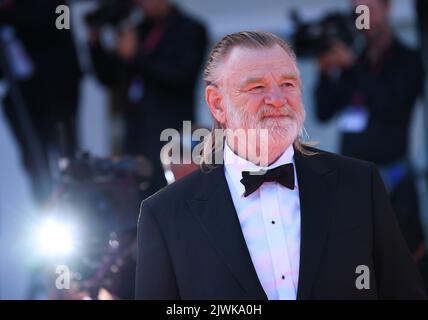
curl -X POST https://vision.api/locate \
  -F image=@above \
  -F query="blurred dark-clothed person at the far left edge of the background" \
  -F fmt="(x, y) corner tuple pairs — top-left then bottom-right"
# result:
(0, 0), (81, 204)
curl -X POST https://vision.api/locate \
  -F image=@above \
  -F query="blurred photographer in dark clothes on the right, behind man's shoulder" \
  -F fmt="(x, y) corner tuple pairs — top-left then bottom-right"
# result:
(315, 0), (426, 282)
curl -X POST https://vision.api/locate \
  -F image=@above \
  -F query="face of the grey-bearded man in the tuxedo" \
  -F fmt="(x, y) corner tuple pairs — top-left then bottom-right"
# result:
(219, 45), (305, 150)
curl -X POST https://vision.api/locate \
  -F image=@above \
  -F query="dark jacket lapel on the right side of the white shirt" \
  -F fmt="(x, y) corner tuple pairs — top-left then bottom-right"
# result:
(295, 151), (338, 300)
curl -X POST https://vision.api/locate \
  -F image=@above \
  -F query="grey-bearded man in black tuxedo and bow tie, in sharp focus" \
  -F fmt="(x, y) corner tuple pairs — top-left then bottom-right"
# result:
(136, 32), (424, 300)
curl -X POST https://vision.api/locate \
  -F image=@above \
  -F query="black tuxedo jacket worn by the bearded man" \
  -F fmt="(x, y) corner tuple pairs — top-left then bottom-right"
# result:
(136, 150), (425, 300)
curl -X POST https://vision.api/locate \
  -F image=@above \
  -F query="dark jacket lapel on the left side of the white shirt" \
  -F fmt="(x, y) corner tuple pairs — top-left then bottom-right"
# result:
(188, 166), (267, 299)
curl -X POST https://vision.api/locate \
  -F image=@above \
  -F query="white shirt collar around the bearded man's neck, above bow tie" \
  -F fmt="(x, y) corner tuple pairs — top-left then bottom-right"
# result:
(223, 142), (297, 196)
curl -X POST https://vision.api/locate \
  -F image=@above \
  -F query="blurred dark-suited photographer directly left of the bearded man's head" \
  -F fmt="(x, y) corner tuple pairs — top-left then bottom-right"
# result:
(87, 0), (207, 193)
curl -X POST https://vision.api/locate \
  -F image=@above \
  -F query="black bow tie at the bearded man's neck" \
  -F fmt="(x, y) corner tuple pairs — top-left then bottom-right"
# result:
(241, 163), (294, 197)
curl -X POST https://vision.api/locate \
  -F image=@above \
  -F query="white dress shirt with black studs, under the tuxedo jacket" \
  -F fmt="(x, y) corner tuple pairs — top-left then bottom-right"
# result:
(224, 143), (300, 300)
